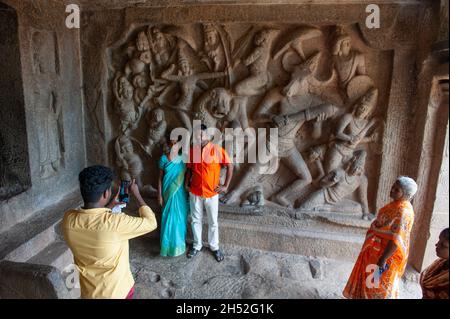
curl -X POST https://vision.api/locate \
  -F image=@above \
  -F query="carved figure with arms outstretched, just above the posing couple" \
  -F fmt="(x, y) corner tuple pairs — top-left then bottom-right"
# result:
(163, 54), (227, 132)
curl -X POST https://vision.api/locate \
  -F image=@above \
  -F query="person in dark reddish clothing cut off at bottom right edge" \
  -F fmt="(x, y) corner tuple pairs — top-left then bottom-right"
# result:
(420, 228), (449, 299)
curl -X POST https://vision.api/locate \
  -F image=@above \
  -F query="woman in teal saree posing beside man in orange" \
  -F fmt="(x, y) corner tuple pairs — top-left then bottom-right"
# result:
(158, 140), (189, 257)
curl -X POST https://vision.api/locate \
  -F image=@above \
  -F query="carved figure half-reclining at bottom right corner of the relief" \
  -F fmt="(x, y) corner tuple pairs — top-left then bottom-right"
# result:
(299, 150), (369, 219)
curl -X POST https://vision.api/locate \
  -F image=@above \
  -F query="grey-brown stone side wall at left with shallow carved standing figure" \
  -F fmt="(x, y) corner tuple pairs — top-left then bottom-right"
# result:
(0, 0), (86, 231)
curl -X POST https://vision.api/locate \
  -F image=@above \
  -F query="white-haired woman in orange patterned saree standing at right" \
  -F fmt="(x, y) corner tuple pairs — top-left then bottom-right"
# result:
(343, 176), (417, 299)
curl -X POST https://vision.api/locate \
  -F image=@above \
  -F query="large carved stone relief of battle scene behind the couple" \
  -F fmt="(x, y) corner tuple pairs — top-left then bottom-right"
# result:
(108, 23), (391, 219)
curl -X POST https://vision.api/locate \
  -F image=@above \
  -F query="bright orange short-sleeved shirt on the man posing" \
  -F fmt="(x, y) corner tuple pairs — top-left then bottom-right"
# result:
(186, 142), (231, 198)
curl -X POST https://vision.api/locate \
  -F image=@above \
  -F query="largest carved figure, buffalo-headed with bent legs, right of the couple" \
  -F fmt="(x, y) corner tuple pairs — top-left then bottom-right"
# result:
(222, 56), (337, 207)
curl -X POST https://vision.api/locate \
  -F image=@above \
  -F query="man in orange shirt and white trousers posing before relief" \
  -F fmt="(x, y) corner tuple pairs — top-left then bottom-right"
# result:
(185, 124), (233, 262)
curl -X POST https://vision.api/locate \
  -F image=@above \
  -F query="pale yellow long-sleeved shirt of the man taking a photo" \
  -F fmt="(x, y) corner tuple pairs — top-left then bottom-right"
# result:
(62, 206), (157, 299)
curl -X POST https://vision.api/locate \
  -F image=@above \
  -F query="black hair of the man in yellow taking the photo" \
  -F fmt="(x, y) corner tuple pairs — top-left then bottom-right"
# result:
(78, 165), (115, 203)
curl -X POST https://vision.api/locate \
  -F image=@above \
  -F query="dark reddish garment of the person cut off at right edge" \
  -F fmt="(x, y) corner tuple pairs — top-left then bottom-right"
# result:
(420, 259), (448, 299)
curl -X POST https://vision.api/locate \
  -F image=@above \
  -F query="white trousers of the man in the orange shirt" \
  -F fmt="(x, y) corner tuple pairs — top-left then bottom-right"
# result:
(189, 193), (219, 251)
